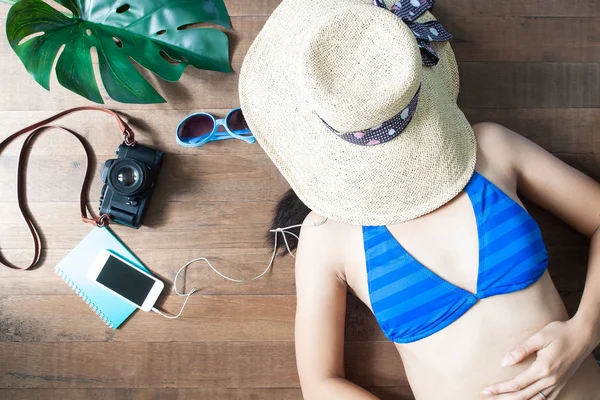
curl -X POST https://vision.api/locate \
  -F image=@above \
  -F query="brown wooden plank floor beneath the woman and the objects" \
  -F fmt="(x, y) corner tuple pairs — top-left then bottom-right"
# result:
(0, 0), (600, 400)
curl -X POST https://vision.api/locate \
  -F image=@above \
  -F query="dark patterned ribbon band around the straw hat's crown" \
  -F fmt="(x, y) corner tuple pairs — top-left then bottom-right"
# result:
(321, 86), (421, 146)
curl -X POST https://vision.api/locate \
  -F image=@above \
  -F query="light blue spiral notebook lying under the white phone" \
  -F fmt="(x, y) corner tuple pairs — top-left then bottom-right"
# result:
(56, 227), (150, 329)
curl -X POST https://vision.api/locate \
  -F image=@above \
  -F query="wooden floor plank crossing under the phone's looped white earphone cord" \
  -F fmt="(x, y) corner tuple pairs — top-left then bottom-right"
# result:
(0, 242), (588, 296)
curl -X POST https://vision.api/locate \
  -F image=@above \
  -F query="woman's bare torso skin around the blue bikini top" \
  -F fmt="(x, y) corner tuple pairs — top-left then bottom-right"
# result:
(334, 140), (600, 400)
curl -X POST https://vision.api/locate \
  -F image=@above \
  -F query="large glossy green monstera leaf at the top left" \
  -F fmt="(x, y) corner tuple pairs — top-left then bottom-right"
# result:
(6, 0), (231, 103)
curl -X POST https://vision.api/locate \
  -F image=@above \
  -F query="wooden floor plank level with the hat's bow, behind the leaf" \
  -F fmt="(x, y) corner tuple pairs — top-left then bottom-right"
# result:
(0, 11), (600, 70)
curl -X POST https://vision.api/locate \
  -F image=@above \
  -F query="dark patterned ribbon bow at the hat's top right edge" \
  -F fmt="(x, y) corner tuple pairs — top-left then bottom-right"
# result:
(373, 0), (452, 67)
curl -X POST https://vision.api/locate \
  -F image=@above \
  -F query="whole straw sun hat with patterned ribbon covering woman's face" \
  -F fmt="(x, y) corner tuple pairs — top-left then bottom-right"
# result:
(239, 0), (476, 225)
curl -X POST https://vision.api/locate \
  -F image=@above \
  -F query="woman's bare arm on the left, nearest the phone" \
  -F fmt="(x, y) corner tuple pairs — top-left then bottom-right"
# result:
(296, 214), (377, 400)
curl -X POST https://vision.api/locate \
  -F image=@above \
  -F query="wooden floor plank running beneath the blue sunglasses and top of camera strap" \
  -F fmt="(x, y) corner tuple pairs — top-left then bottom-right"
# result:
(0, 108), (600, 158)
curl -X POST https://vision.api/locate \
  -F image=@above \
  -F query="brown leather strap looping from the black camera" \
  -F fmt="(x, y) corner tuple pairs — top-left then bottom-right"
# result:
(0, 107), (135, 270)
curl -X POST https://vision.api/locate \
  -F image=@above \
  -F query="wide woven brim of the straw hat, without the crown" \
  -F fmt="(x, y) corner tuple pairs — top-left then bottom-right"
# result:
(240, 0), (477, 225)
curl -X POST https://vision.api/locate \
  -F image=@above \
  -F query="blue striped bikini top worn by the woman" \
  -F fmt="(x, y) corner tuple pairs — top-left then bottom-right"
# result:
(362, 172), (548, 343)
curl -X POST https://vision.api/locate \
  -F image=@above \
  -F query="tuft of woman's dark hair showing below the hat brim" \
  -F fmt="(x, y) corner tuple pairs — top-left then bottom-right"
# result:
(267, 189), (310, 256)
